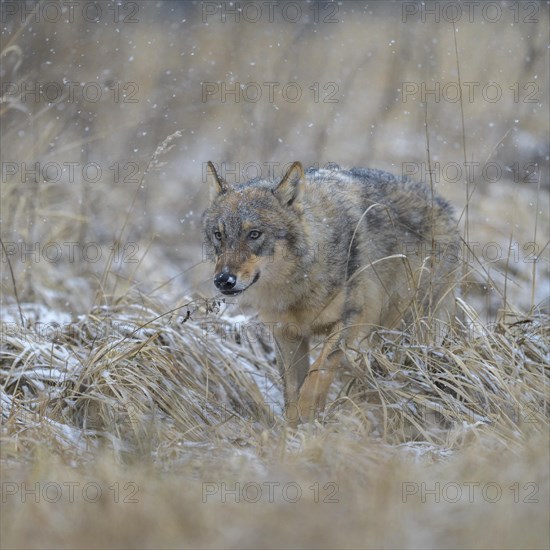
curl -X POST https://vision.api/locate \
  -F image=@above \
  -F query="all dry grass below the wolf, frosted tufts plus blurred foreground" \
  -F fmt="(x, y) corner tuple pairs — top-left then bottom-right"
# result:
(0, 295), (550, 548)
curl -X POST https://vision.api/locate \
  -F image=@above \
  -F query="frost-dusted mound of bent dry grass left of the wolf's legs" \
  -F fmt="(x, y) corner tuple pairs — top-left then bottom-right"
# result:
(0, 299), (280, 464)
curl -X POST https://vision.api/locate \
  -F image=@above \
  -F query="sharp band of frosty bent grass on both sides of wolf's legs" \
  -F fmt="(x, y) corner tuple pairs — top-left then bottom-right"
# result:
(0, 296), (550, 461)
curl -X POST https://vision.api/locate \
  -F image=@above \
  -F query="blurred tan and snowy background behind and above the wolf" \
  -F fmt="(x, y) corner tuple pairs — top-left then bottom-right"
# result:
(0, 0), (549, 320)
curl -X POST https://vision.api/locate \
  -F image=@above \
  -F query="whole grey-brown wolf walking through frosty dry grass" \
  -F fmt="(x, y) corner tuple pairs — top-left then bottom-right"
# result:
(203, 162), (460, 425)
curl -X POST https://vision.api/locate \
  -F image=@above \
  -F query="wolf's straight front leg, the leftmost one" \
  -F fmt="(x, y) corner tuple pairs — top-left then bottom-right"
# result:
(275, 326), (309, 427)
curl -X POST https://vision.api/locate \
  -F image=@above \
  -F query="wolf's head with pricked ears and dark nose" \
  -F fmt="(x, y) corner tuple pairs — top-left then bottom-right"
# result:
(203, 162), (305, 295)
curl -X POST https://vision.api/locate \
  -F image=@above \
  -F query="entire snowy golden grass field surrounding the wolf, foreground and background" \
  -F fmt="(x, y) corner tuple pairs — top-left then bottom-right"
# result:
(0, 0), (550, 549)
